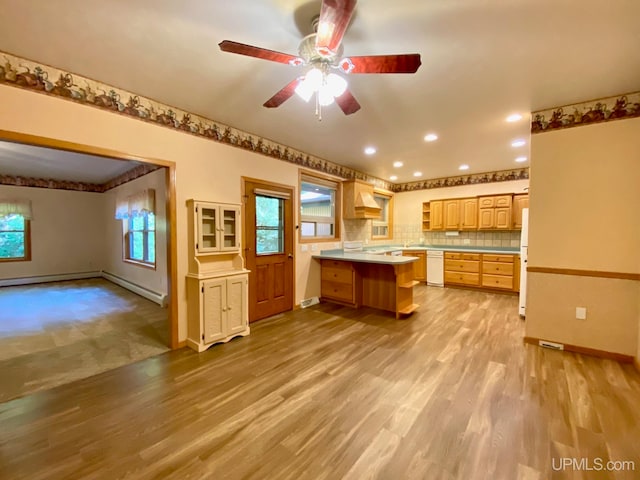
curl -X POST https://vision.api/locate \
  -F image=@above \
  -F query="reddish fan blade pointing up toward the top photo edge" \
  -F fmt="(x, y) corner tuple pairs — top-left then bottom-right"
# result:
(316, 0), (356, 56)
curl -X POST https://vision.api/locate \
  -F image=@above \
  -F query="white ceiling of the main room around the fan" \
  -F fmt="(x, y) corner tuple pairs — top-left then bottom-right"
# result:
(0, 0), (640, 182)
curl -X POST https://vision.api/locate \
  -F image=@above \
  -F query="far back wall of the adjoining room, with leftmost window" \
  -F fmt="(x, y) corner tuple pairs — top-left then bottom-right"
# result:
(0, 185), (105, 279)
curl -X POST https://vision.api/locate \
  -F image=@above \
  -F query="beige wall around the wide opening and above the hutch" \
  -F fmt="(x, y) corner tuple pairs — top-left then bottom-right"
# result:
(0, 85), (310, 340)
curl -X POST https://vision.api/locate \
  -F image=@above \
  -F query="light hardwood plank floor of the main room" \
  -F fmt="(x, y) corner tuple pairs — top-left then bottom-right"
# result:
(0, 286), (640, 480)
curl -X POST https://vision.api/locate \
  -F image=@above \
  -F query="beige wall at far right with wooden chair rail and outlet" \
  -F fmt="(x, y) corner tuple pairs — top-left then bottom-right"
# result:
(526, 119), (640, 356)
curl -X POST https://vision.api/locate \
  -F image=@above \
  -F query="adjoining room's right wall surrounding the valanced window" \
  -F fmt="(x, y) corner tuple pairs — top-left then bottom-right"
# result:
(103, 168), (169, 294)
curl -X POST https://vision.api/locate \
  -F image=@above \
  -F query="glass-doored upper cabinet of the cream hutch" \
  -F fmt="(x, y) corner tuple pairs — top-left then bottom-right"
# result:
(187, 200), (240, 255)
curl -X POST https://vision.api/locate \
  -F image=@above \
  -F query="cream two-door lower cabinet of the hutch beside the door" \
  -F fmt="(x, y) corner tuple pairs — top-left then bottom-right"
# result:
(187, 273), (249, 352)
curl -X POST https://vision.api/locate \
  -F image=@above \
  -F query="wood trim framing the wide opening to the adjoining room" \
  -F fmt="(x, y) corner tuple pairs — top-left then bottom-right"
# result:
(0, 129), (181, 350)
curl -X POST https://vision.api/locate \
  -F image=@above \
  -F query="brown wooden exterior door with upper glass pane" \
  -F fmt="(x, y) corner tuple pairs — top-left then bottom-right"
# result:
(243, 178), (295, 322)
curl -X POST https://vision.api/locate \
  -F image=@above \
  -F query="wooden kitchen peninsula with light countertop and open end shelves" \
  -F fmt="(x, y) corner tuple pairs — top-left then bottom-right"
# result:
(313, 250), (419, 318)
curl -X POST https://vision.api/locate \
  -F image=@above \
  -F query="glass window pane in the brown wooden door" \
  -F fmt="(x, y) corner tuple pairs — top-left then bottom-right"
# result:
(256, 195), (284, 255)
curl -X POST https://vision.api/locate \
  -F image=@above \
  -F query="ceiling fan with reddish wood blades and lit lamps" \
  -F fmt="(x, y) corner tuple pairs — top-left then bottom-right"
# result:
(219, 0), (421, 119)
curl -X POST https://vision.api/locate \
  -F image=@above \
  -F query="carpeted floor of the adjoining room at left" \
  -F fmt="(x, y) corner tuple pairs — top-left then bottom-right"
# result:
(0, 278), (169, 402)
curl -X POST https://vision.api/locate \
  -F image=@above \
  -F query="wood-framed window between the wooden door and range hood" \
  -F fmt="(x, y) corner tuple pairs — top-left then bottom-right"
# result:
(300, 173), (340, 241)
